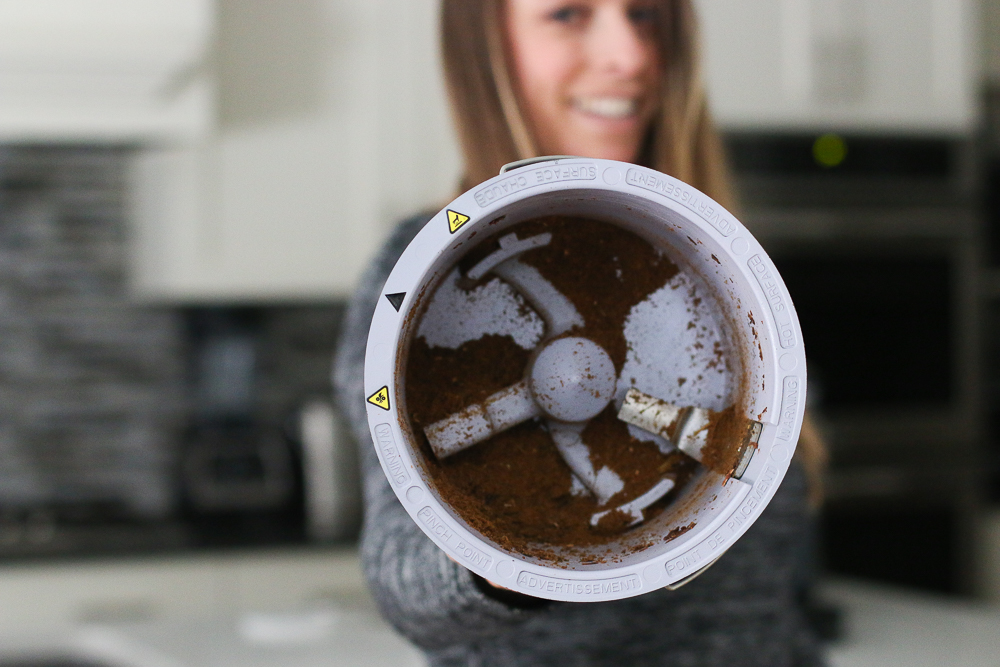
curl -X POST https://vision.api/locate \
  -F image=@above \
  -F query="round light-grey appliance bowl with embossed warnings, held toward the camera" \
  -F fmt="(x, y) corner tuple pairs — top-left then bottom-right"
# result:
(365, 157), (806, 601)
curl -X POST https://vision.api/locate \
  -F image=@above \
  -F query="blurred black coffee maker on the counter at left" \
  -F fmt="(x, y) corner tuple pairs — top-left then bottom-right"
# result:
(181, 308), (303, 545)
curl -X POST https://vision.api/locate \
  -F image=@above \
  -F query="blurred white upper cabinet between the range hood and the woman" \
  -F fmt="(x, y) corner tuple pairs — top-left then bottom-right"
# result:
(131, 0), (458, 302)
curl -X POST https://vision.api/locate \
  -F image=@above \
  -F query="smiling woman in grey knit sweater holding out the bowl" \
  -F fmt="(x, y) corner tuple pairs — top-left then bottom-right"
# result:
(335, 0), (819, 666)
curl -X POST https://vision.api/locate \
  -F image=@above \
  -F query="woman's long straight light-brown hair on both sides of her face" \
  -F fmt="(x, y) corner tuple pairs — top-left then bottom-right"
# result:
(441, 0), (733, 207)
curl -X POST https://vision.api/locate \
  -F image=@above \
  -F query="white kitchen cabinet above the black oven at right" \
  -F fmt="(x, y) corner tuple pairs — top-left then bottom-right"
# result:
(697, 0), (980, 135)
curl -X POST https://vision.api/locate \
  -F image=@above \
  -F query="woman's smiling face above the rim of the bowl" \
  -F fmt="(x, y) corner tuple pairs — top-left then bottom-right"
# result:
(504, 0), (661, 162)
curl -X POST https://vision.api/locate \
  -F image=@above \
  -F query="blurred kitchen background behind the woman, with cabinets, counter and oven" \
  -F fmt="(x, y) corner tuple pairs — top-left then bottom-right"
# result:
(0, 0), (1000, 665)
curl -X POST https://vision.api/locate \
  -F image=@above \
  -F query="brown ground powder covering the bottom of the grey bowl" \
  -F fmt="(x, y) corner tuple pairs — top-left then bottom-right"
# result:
(405, 217), (731, 559)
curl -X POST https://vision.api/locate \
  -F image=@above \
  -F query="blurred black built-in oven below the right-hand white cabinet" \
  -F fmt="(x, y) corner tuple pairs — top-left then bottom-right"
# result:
(725, 128), (980, 593)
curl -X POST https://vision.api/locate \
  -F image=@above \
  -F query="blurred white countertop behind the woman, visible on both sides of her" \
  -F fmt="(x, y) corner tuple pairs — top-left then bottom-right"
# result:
(0, 550), (1000, 667)
